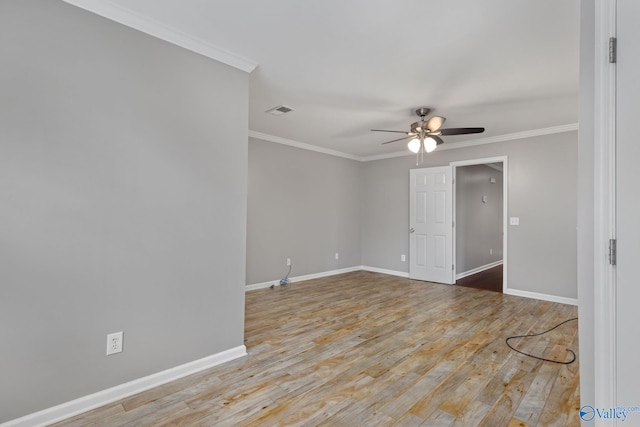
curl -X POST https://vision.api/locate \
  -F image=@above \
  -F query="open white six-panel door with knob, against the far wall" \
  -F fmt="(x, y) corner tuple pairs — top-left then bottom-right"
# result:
(409, 166), (455, 284)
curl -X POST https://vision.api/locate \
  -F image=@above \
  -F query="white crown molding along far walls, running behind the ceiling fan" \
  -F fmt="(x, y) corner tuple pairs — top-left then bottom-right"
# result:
(249, 123), (579, 162)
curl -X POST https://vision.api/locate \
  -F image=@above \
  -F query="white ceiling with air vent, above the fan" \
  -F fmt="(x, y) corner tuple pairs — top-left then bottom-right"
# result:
(67, 0), (580, 158)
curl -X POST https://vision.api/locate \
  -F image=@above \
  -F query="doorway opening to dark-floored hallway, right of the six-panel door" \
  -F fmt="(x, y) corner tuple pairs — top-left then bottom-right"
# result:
(452, 157), (507, 292)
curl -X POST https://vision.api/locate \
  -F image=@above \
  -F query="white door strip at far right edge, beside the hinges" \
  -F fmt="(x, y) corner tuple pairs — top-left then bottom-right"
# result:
(615, 0), (640, 408)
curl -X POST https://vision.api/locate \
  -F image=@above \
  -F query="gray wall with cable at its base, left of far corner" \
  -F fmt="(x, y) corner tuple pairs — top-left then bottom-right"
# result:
(247, 139), (363, 284)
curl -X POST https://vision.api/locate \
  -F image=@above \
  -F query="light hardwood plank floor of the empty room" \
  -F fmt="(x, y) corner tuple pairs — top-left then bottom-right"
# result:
(57, 271), (580, 427)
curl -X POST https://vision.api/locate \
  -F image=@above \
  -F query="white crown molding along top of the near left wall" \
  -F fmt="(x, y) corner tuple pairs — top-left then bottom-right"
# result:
(63, 0), (258, 73)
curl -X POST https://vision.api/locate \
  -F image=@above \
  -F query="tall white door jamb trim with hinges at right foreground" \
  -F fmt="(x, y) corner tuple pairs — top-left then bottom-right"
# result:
(593, 0), (617, 414)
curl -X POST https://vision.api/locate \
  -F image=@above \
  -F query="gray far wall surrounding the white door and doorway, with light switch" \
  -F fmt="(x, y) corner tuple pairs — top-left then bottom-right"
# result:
(362, 131), (578, 298)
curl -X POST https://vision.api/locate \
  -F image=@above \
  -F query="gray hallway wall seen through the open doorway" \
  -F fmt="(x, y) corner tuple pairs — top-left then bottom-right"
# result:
(455, 163), (504, 274)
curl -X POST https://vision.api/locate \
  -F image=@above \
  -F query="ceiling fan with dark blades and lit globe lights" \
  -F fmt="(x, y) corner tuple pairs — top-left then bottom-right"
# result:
(371, 107), (484, 160)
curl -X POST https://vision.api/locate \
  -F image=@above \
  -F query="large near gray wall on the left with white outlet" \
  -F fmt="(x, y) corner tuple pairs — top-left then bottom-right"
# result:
(0, 0), (248, 422)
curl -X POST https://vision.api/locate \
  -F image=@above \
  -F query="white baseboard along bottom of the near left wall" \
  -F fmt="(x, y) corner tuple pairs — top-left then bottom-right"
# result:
(0, 345), (247, 427)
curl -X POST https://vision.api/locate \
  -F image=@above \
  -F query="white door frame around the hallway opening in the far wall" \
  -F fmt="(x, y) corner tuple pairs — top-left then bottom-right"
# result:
(449, 156), (509, 294)
